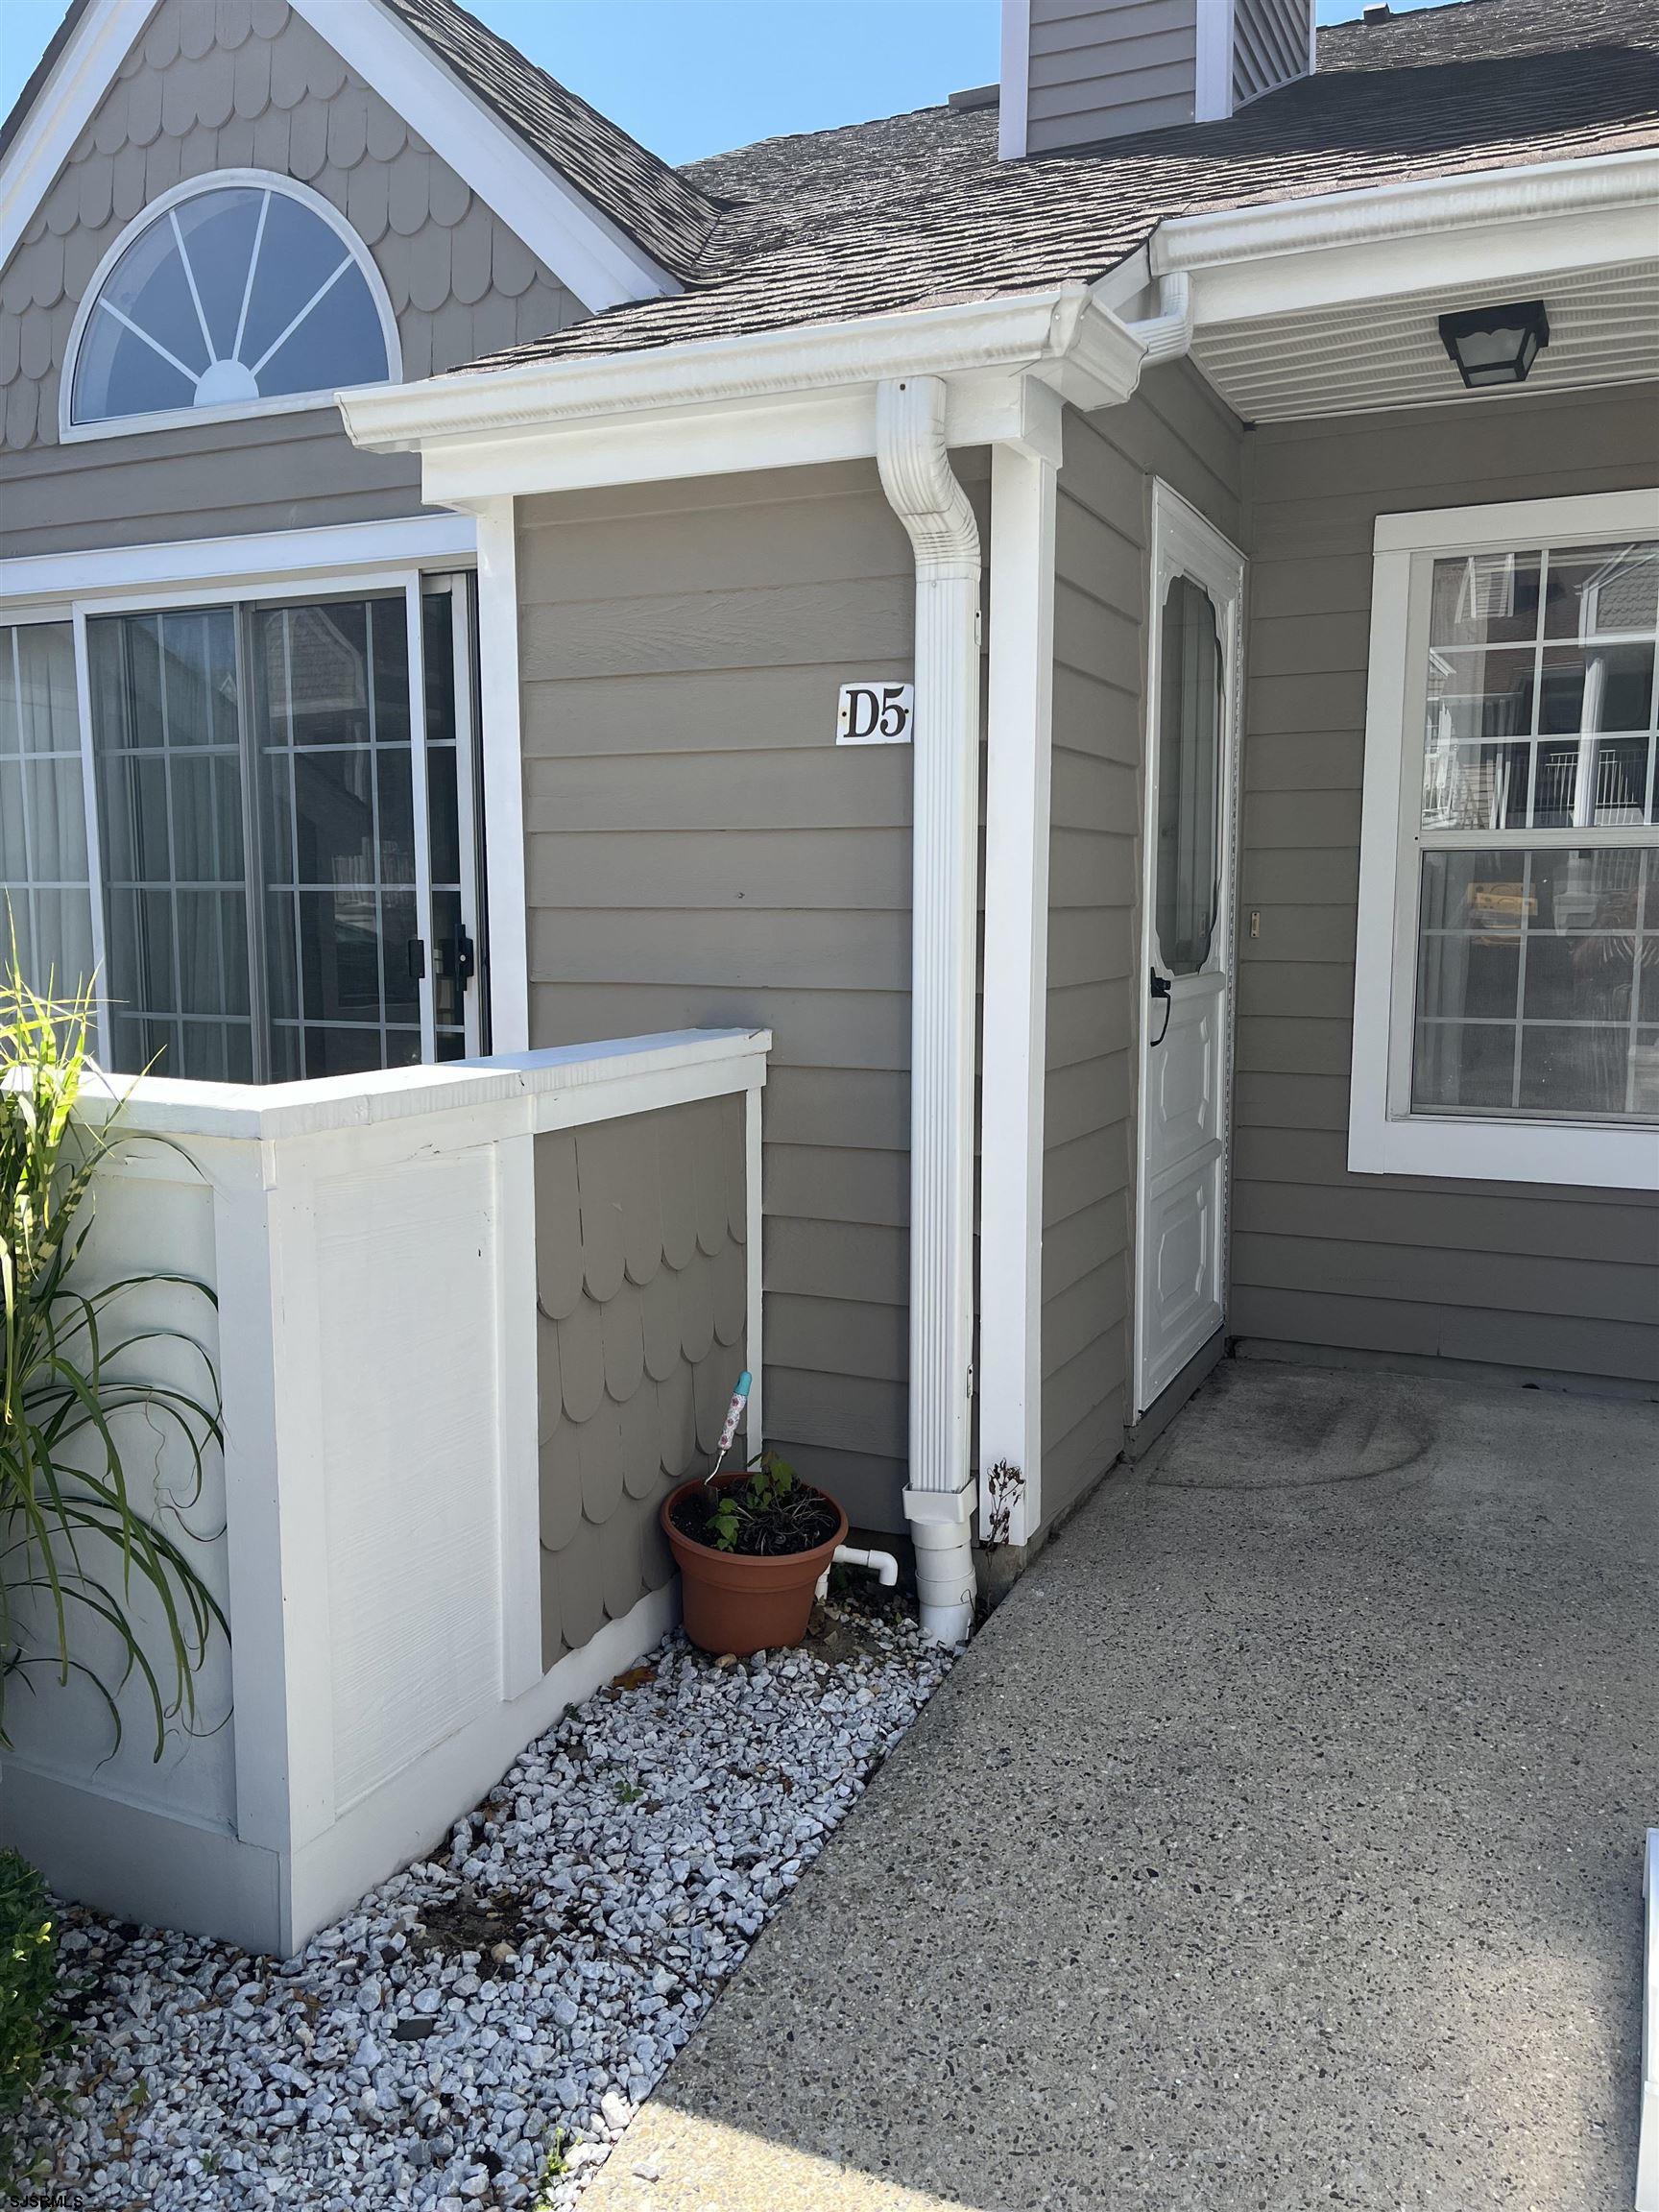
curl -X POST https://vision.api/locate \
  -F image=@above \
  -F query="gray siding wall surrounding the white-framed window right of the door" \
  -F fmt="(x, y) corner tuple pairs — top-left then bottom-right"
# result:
(1230, 387), (1659, 1382)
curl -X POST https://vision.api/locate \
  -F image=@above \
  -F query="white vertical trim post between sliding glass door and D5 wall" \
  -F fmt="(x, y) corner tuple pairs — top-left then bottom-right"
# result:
(473, 497), (531, 1053)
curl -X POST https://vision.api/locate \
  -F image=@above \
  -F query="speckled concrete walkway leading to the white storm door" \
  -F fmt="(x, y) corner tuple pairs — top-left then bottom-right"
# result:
(584, 1367), (1659, 2212)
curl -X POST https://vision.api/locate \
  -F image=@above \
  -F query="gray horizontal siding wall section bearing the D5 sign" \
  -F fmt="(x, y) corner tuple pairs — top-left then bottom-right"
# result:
(519, 465), (928, 1528)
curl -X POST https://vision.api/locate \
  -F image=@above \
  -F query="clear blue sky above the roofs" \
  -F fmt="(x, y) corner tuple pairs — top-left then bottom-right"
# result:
(0, 0), (1468, 161)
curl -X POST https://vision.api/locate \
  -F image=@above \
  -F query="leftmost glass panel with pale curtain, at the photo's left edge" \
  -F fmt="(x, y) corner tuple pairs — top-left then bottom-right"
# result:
(0, 621), (95, 998)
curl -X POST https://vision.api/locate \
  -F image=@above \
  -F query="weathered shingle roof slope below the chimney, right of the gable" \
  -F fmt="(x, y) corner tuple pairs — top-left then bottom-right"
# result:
(448, 0), (1659, 373)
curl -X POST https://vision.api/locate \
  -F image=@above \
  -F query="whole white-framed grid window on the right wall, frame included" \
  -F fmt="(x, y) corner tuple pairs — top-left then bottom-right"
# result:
(1349, 493), (1659, 1188)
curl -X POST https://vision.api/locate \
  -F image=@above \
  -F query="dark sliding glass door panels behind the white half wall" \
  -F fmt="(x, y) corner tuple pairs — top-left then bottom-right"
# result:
(86, 590), (478, 1082)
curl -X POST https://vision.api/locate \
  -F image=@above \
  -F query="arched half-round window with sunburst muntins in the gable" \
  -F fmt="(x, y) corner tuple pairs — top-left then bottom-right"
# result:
(62, 170), (398, 438)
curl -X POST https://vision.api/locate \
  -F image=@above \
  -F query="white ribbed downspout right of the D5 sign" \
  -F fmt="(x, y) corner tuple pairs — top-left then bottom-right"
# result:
(876, 376), (980, 1644)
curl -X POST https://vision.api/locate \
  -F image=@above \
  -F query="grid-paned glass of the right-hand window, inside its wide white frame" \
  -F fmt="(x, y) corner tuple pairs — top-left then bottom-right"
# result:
(1411, 540), (1659, 1121)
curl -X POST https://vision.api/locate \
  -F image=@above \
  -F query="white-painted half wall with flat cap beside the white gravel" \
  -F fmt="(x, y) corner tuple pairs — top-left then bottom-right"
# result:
(0, 1031), (772, 1956)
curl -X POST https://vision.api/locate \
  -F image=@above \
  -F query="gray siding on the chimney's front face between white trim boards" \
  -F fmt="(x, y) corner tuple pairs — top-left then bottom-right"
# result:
(1026, 0), (1199, 153)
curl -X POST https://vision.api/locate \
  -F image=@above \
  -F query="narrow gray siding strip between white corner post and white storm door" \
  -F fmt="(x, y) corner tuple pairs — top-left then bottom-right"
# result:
(1042, 365), (1241, 1520)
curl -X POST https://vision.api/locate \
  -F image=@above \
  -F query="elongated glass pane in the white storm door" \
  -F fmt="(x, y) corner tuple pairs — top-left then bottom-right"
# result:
(1155, 575), (1221, 975)
